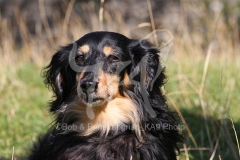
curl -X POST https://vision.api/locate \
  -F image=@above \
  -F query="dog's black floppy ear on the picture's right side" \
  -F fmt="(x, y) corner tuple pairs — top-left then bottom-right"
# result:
(129, 39), (164, 92)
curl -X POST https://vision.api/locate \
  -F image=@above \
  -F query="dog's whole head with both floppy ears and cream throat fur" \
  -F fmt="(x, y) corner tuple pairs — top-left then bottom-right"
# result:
(45, 32), (165, 139)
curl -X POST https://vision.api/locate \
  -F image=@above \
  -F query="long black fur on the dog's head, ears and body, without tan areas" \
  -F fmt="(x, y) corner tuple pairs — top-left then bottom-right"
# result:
(29, 32), (182, 160)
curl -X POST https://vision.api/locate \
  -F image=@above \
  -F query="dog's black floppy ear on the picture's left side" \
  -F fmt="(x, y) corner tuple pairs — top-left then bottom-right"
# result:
(43, 45), (76, 112)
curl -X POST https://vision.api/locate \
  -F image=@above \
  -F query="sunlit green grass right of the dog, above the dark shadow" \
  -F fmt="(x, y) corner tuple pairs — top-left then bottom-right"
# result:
(166, 57), (240, 120)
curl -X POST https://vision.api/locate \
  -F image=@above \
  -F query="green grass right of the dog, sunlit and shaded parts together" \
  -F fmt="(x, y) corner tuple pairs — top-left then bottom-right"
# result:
(165, 57), (240, 159)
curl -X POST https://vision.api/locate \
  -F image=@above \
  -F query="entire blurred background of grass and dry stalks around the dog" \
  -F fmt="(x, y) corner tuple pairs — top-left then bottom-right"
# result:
(0, 0), (240, 160)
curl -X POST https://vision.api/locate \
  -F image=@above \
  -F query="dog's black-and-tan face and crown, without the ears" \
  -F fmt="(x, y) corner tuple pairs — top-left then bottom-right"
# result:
(75, 32), (131, 107)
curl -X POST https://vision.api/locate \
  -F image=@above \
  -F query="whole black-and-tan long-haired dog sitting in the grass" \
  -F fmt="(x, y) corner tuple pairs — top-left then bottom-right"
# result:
(29, 32), (182, 160)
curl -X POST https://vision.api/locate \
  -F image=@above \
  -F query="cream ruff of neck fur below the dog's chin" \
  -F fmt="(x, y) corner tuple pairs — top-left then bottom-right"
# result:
(63, 97), (143, 141)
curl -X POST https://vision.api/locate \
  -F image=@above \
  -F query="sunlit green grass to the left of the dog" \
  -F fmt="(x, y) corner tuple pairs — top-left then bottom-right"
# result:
(0, 64), (50, 158)
